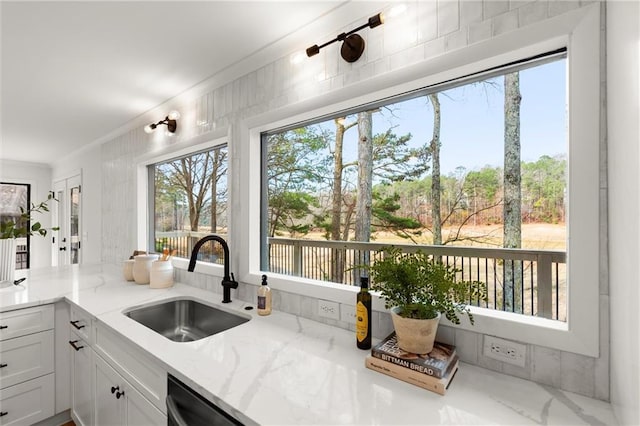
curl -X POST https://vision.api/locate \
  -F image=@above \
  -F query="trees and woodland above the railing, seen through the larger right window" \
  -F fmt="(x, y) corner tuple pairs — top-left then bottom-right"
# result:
(266, 62), (567, 253)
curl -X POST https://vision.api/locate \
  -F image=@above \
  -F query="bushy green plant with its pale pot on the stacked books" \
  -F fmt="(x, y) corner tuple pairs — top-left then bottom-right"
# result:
(365, 246), (486, 354)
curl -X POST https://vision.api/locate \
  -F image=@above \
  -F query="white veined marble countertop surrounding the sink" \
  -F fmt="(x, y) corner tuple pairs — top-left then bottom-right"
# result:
(0, 265), (617, 425)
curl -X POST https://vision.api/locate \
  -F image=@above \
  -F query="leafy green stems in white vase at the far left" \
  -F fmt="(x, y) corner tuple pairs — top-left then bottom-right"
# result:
(0, 193), (58, 281)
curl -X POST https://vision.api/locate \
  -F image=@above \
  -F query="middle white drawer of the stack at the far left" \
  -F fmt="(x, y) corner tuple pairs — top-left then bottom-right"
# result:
(0, 330), (54, 388)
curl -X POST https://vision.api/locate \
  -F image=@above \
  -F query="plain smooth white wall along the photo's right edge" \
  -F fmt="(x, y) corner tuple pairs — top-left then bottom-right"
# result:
(607, 1), (640, 425)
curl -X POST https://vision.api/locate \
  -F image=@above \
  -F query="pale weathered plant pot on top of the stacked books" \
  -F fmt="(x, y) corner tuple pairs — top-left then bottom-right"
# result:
(391, 307), (440, 354)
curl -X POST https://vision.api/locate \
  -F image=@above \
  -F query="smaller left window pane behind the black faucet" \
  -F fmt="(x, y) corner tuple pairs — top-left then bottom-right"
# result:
(148, 145), (228, 263)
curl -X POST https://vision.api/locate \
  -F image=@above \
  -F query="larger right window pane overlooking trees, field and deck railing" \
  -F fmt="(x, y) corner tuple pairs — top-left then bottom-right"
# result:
(261, 50), (568, 321)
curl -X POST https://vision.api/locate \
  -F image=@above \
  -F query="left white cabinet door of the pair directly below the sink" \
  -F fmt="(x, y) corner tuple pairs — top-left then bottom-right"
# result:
(92, 355), (126, 426)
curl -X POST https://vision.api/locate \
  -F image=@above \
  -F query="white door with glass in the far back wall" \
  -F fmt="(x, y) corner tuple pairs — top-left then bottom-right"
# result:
(52, 175), (82, 266)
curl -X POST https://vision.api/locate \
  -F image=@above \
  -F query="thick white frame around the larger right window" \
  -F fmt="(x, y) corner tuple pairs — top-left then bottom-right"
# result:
(239, 4), (601, 357)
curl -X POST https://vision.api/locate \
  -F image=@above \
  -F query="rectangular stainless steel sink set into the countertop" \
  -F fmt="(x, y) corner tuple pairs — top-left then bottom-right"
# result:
(123, 298), (250, 342)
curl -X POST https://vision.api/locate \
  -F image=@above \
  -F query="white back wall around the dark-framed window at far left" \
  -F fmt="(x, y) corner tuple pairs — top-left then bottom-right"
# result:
(0, 160), (53, 268)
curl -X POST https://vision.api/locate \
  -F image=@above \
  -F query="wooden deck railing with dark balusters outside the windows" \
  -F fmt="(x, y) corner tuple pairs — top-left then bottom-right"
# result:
(156, 232), (567, 321)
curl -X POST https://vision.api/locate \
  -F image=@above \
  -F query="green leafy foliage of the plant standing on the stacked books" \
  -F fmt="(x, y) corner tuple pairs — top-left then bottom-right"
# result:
(364, 246), (487, 324)
